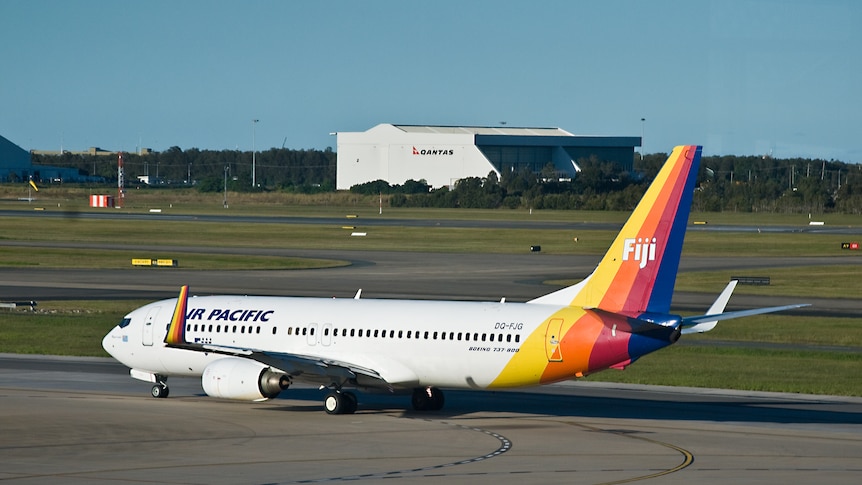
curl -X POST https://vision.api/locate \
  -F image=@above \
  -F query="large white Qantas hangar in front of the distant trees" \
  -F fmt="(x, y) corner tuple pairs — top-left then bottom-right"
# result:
(336, 123), (641, 190)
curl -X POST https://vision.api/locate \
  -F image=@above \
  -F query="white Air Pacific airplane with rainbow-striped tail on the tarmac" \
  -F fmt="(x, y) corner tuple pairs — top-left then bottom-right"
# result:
(102, 145), (807, 414)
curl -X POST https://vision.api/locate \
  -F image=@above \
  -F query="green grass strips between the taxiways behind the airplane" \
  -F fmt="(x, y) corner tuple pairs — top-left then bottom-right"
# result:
(0, 199), (862, 396)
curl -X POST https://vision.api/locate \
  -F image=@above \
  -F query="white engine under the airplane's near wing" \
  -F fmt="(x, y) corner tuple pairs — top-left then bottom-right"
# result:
(201, 357), (290, 401)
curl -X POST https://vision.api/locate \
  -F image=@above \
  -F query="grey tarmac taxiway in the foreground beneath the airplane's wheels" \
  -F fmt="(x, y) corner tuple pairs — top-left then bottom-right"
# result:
(0, 354), (862, 485)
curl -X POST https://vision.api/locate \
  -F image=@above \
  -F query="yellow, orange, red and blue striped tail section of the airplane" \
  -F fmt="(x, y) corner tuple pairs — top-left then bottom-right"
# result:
(489, 146), (701, 387)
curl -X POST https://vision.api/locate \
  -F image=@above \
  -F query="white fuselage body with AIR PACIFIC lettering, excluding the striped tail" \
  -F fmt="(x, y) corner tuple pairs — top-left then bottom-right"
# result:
(103, 296), (560, 388)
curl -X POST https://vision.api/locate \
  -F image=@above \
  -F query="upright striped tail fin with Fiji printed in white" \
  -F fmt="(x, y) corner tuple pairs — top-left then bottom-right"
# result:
(530, 145), (701, 315)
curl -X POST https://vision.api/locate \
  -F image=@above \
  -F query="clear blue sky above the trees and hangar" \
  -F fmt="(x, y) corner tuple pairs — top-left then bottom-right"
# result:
(0, 0), (862, 162)
